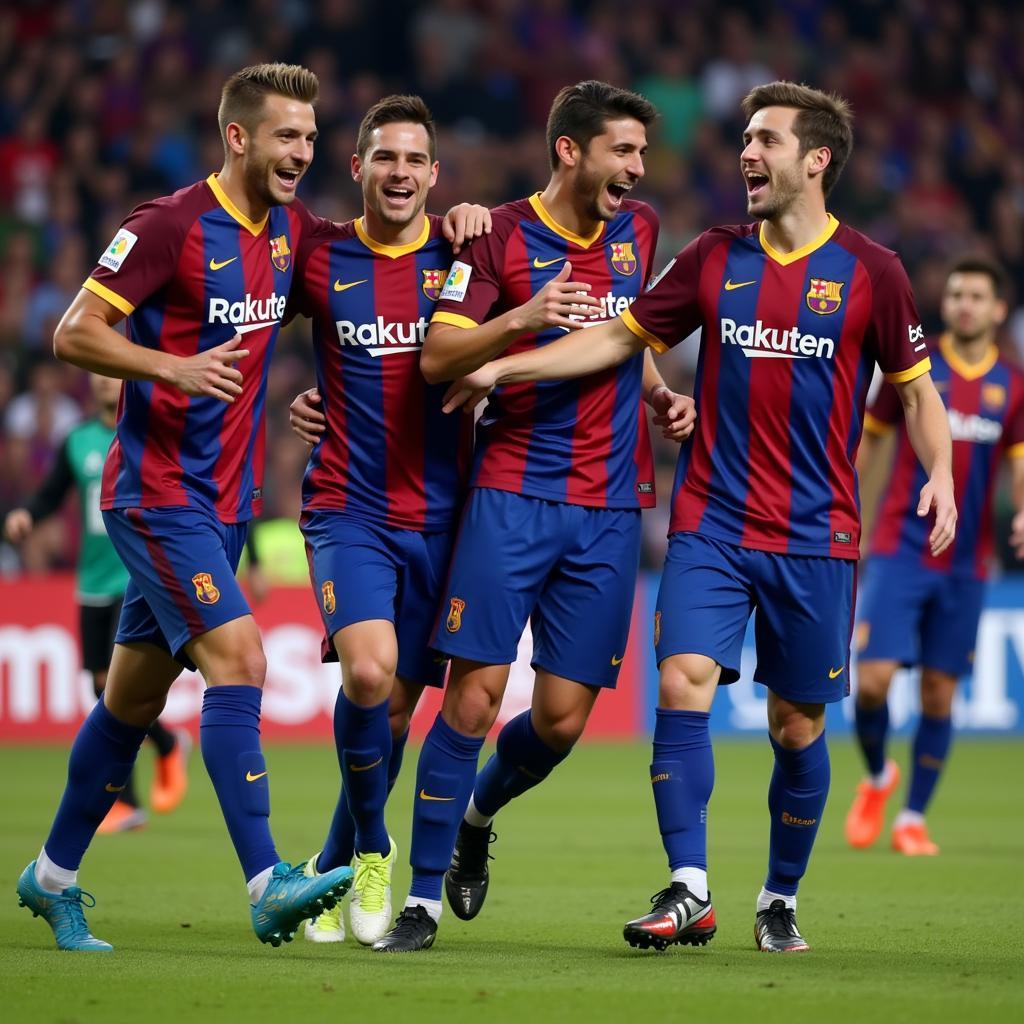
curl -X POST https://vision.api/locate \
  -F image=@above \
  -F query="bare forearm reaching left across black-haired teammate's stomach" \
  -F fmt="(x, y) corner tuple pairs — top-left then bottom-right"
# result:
(444, 316), (645, 413)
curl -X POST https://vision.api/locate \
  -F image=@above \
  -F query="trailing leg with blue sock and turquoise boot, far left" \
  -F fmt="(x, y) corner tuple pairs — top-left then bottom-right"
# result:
(17, 643), (181, 950)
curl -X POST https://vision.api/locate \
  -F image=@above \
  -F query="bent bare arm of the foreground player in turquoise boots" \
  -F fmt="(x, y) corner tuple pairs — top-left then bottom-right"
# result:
(53, 288), (249, 402)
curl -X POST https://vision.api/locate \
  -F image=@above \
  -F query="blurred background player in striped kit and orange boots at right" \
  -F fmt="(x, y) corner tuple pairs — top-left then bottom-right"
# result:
(846, 256), (1024, 856)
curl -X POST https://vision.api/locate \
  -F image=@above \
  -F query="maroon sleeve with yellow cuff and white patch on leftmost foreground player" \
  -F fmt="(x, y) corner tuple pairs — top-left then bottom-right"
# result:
(82, 202), (187, 316)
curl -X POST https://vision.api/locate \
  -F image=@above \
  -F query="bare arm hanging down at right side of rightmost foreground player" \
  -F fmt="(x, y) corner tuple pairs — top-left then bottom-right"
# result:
(896, 374), (956, 555)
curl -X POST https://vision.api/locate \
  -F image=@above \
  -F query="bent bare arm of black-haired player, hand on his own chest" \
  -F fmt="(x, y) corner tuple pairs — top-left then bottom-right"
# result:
(420, 260), (601, 384)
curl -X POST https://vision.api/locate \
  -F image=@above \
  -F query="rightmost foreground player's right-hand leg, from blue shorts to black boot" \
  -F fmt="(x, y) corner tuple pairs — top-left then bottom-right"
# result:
(751, 552), (856, 952)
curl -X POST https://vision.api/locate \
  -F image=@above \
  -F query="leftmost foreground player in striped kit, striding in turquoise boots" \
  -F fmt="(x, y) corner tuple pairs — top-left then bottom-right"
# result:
(18, 65), (351, 950)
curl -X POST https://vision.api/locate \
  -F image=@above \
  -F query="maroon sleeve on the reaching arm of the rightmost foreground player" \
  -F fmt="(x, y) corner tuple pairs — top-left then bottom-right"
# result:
(623, 234), (705, 352)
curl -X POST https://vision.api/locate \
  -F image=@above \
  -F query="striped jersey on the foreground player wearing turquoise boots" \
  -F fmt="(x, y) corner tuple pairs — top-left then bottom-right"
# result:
(83, 174), (314, 522)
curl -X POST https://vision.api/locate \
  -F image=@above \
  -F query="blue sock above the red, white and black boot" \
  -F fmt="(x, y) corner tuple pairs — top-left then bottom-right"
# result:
(650, 708), (715, 870)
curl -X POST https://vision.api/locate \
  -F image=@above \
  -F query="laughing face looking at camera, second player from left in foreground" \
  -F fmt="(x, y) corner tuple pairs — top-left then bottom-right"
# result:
(352, 121), (437, 227)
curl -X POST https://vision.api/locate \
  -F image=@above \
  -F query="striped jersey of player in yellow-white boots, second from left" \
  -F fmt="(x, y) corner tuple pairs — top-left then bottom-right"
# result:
(292, 217), (473, 531)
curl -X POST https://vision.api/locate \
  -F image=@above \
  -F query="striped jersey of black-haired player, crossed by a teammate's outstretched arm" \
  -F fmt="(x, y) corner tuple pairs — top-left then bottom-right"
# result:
(433, 195), (657, 509)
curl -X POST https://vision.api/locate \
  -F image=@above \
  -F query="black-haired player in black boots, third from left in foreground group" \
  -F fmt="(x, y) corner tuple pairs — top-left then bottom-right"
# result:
(374, 82), (692, 952)
